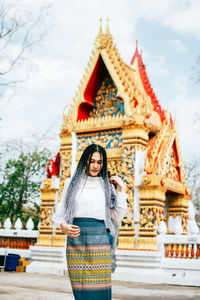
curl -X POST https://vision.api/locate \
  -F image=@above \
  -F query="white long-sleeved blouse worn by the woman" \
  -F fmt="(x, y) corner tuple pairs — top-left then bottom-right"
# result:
(53, 176), (127, 227)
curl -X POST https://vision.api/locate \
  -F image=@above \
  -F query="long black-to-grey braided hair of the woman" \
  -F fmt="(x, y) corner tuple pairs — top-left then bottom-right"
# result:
(64, 144), (116, 229)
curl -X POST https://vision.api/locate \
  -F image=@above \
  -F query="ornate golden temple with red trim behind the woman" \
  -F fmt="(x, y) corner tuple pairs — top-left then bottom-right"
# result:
(29, 23), (199, 284)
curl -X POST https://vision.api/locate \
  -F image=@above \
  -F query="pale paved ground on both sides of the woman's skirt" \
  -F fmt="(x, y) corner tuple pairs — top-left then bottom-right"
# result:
(0, 271), (200, 300)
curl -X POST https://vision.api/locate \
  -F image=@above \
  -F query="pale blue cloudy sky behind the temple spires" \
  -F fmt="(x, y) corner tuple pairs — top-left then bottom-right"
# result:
(0, 0), (200, 164)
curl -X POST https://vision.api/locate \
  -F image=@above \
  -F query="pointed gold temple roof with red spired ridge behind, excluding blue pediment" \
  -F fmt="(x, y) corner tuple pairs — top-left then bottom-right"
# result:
(62, 22), (164, 132)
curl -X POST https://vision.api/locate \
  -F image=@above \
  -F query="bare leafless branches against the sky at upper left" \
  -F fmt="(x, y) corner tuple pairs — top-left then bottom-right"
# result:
(0, 0), (48, 96)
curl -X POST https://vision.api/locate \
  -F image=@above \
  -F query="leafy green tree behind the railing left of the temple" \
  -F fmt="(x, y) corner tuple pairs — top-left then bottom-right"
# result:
(0, 148), (51, 223)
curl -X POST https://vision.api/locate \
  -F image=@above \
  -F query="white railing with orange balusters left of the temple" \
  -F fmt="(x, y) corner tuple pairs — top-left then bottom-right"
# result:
(0, 218), (38, 250)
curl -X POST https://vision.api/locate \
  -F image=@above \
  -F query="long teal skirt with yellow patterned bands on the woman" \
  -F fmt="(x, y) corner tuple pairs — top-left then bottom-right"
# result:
(67, 218), (111, 300)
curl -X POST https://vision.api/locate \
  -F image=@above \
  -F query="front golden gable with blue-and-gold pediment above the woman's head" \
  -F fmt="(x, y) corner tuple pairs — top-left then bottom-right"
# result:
(61, 20), (159, 133)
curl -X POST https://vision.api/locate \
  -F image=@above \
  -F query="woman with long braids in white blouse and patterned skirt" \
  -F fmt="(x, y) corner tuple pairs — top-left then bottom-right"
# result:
(54, 144), (127, 300)
